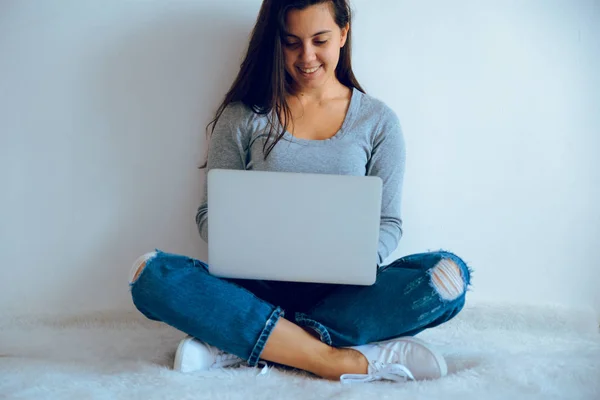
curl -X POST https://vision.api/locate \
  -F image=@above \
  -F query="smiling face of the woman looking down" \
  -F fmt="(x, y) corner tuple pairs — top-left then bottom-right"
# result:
(282, 3), (348, 90)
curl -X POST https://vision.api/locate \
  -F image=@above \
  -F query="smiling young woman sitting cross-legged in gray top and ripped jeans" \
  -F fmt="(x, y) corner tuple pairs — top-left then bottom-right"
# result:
(130, 0), (470, 382)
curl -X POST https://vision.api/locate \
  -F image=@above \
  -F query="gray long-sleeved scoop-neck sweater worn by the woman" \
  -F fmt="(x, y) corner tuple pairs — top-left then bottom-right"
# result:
(196, 89), (406, 265)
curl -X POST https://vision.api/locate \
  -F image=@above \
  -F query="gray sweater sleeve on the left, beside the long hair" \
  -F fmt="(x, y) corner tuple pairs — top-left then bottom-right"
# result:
(196, 104), (247, 243)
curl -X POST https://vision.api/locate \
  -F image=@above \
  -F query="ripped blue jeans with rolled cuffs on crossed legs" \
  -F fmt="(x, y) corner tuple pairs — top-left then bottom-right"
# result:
(130, 250), (471, 366)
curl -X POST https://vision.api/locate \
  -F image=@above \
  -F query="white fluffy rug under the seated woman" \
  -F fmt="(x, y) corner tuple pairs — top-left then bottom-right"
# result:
(0, 304), (600, 400)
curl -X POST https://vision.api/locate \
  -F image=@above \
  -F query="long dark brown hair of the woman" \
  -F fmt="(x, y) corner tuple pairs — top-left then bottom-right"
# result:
(202, 0), (364, 168)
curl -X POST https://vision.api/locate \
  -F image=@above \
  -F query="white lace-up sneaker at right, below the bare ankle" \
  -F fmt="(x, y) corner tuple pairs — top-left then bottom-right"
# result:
(340, 337), (448, 383)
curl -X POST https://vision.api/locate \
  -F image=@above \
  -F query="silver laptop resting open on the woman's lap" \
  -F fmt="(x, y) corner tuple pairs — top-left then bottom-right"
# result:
(207, 169), (382, 285)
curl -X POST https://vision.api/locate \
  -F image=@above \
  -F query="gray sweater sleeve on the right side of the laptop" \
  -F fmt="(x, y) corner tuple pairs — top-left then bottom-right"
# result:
(367, 110), (406, 266)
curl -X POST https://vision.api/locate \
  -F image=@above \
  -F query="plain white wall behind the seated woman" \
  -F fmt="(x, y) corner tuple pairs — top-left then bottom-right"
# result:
(0, 0), (600, 314)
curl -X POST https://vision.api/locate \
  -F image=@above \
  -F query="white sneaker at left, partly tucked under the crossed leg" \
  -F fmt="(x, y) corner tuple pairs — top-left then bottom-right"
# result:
(173, 336), (244, 372)
